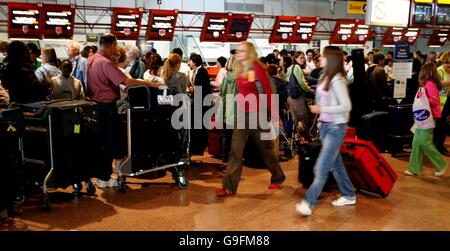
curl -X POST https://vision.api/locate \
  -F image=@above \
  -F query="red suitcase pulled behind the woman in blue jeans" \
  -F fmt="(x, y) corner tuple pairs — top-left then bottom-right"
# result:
(340, 138), (397, 198)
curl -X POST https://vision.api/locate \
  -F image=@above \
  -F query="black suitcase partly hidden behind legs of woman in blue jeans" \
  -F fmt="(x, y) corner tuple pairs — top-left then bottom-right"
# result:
(298, 141), (335, 188)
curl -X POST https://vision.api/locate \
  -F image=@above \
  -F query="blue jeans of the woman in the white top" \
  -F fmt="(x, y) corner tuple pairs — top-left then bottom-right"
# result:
(305, 123), (355, 208)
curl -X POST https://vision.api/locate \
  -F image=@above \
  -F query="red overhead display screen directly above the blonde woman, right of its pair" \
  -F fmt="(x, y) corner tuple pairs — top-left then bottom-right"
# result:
(226, 14), (254, 42)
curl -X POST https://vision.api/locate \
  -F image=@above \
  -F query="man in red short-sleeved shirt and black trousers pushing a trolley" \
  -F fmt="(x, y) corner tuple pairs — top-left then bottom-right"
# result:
(86, 34), (161, 188)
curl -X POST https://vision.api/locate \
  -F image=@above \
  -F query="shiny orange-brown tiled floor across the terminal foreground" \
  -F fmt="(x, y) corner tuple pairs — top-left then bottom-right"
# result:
(0, 150), (450, 230)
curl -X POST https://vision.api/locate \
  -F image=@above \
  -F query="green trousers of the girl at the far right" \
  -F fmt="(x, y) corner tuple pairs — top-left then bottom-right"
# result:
(408, 128), (448, 174)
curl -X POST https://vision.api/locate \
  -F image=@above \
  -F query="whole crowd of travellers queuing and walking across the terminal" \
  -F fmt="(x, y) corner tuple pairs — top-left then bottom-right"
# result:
(0, 34), (450, 220)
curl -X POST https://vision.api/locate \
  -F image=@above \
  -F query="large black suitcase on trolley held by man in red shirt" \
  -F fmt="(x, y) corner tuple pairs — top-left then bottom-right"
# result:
(128, 86), (187, 173)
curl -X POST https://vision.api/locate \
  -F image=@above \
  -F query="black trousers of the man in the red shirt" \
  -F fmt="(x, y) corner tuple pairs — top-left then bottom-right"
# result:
(95, 103), (123, 180)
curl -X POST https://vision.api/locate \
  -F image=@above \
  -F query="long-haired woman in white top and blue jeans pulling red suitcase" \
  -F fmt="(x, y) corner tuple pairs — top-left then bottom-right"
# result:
(296, 46), (356, 216)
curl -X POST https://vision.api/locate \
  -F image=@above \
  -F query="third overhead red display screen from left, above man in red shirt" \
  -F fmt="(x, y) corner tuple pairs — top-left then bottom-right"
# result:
(111, 8), (143, 40)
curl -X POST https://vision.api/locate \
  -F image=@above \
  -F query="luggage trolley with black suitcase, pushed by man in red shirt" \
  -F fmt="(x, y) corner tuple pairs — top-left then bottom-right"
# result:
(114, 86), (190, 192)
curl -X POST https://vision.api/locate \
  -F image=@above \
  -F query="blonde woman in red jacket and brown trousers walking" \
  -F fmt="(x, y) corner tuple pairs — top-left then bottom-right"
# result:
(216, 42), (286, 196)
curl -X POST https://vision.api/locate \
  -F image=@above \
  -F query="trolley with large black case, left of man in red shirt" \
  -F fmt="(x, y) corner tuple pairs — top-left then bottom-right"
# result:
(21, 100), (99, 211)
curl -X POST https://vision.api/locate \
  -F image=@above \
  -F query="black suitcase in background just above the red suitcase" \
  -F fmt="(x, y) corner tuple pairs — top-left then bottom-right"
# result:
(356, 112), (390, 152)
